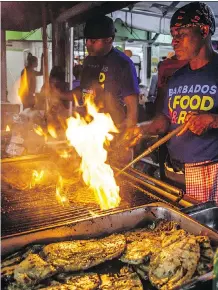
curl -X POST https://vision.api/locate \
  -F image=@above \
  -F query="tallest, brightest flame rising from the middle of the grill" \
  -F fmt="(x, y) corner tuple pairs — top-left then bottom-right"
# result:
(66, 96), (120, 210)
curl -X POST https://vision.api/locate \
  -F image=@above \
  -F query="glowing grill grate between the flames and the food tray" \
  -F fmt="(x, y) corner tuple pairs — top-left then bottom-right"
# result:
(2, 181), (155, 238)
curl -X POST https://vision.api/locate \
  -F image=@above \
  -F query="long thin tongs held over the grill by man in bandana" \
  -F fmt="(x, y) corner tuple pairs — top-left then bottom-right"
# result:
(116, 124), (184, 176)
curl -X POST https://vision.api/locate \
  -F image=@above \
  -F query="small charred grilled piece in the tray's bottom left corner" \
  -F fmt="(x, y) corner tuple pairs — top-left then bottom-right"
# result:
(14, 254), (56, 289)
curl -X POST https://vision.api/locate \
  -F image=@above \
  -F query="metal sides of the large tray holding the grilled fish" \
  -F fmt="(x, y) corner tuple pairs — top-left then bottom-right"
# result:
(2, 203), (218, 289)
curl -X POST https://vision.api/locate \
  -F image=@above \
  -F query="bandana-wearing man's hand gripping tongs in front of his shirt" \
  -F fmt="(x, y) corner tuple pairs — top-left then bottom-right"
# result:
(177, 112), (214, 136)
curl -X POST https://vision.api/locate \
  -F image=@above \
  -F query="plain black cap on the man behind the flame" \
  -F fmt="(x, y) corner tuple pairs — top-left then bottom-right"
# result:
(84, 15), (116, 39)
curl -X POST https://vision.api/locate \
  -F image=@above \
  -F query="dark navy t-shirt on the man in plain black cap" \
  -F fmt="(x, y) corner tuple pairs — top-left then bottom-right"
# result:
(81, 48), (139, 104)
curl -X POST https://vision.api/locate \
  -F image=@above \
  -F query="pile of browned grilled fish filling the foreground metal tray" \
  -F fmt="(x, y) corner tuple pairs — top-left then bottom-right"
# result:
(1, 220), (214, 290)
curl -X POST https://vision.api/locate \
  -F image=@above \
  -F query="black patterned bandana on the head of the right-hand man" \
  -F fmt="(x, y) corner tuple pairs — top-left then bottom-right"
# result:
(170, 2), (216, 35)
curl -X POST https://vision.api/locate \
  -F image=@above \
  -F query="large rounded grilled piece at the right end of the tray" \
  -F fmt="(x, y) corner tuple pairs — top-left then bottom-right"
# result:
(149, 235), (200, 290)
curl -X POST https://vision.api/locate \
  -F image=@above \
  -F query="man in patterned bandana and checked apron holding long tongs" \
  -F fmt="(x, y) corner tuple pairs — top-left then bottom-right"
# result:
(126, 2), (218, 202)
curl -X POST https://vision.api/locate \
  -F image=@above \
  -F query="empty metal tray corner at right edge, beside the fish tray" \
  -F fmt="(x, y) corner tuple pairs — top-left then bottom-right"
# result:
(190, 207), (218, 233)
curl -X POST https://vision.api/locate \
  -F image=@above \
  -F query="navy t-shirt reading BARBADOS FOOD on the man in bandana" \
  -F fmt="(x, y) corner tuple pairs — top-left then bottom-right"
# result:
(163, 55), (218, 163)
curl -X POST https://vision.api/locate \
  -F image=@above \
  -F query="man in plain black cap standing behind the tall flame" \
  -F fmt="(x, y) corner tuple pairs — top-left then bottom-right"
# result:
(81, 16), (139, 127)
